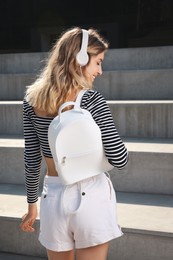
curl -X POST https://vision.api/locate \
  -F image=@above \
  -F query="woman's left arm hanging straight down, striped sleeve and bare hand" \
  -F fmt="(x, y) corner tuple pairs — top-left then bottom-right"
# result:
(20, 100), (42, 232)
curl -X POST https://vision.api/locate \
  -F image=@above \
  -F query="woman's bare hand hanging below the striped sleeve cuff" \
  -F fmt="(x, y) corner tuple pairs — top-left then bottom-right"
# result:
(20, 203), (38, 232)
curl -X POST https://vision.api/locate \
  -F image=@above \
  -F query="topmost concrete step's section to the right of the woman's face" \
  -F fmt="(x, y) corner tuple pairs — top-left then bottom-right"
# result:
(103, 46), (173, 71)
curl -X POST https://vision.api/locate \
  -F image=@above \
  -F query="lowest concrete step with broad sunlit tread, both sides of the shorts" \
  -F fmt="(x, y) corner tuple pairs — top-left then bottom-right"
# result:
(0, 184), (173, 260)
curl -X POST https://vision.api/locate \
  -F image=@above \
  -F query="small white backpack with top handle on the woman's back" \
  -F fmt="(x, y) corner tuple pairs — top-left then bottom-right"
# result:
(48, 90), (114, 185)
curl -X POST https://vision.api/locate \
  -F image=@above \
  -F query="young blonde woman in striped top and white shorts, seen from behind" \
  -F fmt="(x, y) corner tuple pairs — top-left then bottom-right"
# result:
(21, 27), (128, 260)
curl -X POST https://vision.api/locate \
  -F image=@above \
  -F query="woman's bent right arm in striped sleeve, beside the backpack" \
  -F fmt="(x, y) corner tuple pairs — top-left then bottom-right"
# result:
(81, 90), (128, 169)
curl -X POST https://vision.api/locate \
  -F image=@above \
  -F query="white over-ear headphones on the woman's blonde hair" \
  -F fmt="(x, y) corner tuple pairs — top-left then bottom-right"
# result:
(76, 29), (89, 66)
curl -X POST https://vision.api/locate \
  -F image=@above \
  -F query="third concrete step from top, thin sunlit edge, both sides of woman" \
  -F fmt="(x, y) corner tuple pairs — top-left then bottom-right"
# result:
(0, 100), (173, 138)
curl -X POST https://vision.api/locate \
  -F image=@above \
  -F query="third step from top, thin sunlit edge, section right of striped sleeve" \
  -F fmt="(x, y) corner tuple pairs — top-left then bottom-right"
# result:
(108, 100), (173, 138)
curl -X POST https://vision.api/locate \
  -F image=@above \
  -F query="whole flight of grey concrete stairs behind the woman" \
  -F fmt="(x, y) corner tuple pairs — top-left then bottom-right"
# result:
(0, 46), (173, 260)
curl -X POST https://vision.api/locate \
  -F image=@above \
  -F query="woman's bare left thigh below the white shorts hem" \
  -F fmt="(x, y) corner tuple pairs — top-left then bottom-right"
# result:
(47, 250), (74, 260)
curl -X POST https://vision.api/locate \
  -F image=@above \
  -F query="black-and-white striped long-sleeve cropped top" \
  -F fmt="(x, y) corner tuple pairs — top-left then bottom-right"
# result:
(23, 90), (128, 203)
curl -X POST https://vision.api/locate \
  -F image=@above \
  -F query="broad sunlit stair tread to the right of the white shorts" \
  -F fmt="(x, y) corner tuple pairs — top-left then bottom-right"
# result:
(117, 191), (173, 236)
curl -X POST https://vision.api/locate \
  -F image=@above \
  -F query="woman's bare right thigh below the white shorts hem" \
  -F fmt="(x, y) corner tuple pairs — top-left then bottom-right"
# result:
(75, 242), (109, 260)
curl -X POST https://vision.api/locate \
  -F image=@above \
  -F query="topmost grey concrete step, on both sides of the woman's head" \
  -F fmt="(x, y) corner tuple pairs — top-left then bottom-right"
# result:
(0, 46), (173, 73)
